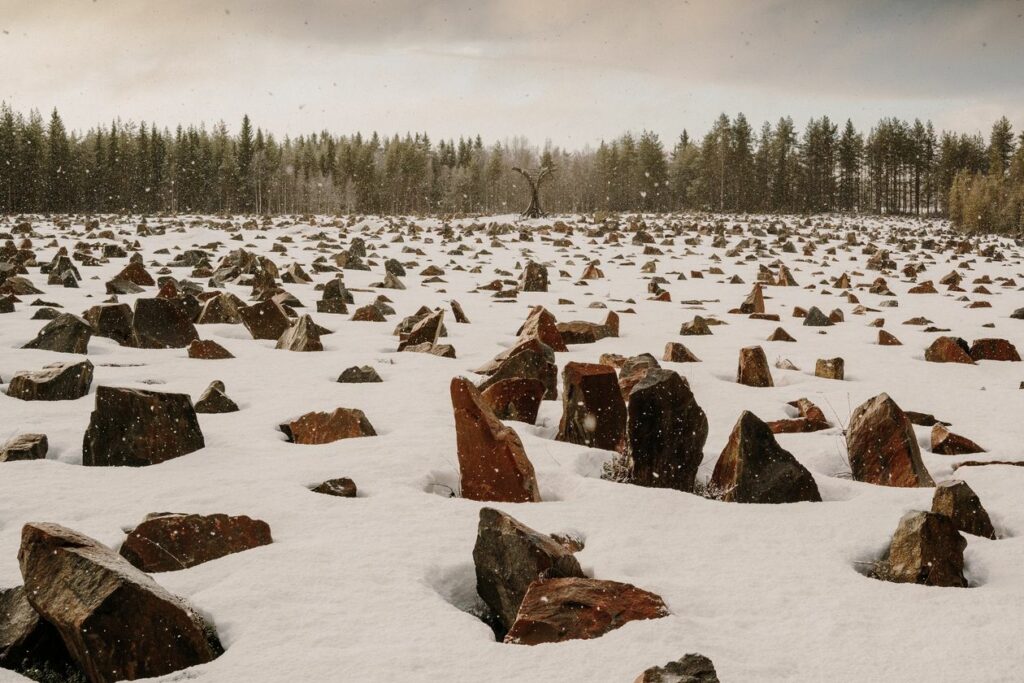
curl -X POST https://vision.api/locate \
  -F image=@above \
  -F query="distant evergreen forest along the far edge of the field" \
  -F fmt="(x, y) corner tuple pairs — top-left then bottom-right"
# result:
(0, 103), (1024, 233)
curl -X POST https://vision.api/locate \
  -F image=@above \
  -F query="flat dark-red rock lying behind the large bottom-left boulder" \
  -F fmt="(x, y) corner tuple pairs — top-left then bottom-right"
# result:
(120, 514), (272, 573)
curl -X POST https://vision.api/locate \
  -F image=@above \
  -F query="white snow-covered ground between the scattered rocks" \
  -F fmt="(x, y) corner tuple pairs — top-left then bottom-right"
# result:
(0, 216), (1024, 683)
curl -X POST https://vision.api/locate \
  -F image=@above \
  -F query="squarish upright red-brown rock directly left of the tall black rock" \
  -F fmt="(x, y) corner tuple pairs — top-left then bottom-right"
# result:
(555, 361), (626, 451)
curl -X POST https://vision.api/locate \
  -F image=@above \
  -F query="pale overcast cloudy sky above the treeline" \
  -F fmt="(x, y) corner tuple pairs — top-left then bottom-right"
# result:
(0, 0), (1024, 148)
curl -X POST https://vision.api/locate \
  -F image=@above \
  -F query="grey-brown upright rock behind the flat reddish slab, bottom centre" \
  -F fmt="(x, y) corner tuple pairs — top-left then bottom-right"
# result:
(473, 508), (585, 631)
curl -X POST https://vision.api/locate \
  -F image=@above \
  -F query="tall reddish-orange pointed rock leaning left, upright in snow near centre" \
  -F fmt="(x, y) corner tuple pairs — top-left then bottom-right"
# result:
(451, 377), (541, 503)
